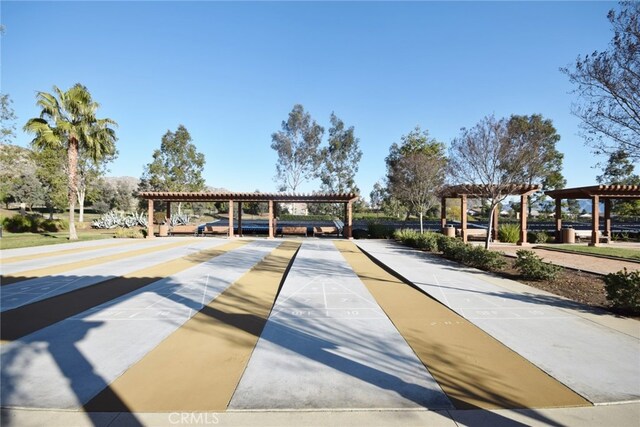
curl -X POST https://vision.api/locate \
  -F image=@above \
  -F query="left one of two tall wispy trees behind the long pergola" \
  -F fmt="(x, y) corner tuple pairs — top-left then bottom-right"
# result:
(271, 104), (324, 192)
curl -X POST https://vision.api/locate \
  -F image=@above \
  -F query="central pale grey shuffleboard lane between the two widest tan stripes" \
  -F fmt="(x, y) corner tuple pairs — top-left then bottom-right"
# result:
(229, 241), (452, 409)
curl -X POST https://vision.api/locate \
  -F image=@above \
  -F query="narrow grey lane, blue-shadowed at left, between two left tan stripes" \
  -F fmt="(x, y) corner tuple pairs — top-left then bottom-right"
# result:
(0, 239), (227, 312)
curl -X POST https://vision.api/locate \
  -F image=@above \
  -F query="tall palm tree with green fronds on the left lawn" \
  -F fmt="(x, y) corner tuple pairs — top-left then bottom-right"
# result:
(24, 83), (117, 240)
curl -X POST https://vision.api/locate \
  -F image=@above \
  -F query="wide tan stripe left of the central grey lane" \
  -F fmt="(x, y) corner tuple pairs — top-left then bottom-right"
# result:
(84, 242), (300, 412)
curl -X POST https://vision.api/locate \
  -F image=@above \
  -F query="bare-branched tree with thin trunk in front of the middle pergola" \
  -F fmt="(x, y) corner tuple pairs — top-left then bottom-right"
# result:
(449, 116), (535, 249)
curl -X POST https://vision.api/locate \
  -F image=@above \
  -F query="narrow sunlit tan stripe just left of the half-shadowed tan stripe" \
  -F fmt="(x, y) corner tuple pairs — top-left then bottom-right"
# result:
(1, 239), (202, 286)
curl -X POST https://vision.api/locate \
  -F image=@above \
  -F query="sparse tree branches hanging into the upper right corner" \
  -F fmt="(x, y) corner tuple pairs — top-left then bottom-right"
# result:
(561, 1), (640, 160)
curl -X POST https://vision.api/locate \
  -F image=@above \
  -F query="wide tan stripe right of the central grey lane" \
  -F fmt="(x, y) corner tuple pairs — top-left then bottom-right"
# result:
(336, 242), (590, 409)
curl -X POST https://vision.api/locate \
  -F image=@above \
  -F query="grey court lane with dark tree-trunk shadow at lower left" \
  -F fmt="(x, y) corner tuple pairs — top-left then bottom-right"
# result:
(0, 241), (278, 409)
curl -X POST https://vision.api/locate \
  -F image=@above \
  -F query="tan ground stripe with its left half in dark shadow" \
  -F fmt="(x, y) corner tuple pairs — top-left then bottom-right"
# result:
(0, 240), (249, 341)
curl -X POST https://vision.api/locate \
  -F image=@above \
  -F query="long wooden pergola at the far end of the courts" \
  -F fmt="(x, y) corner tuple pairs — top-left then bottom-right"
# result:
(138, 191), (358, 239)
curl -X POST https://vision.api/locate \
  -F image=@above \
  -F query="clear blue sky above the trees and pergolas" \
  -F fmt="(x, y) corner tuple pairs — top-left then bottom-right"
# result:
(0, 1), (617, 199)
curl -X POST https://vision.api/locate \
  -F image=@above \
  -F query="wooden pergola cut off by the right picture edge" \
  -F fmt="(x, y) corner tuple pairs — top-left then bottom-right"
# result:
(545, 185), (640, 246)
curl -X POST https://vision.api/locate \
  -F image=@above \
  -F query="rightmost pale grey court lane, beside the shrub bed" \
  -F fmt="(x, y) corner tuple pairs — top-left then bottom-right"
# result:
(358, 241), (640, 404)
